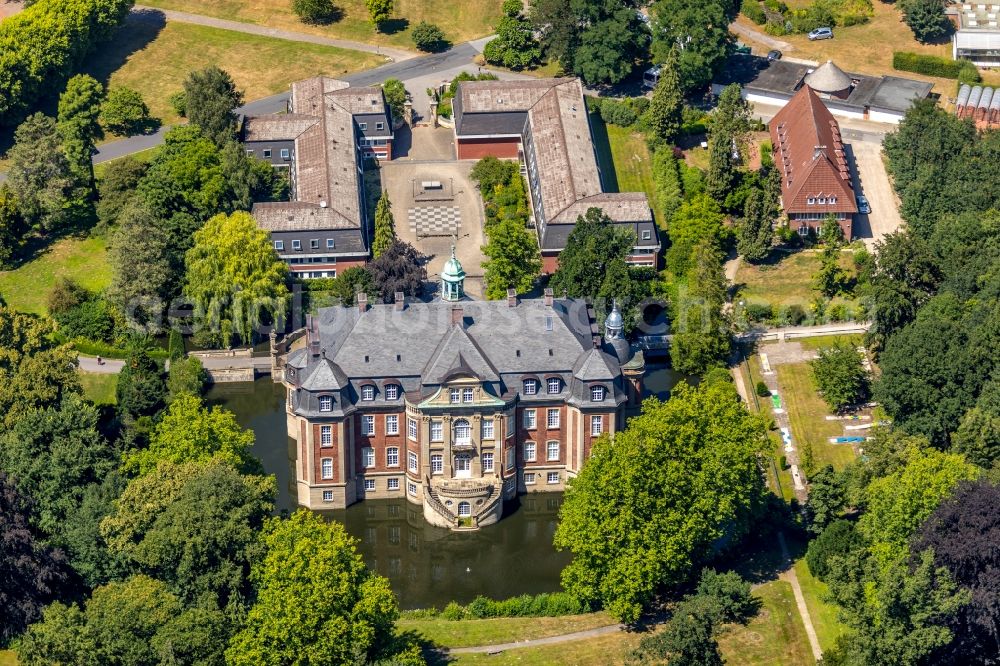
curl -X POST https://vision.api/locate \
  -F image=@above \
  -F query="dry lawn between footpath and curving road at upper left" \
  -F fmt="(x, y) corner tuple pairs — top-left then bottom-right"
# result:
(85, 20), (384, 124)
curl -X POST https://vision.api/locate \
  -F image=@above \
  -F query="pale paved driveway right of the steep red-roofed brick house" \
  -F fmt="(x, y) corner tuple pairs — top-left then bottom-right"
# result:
(846, 142), (903, 249)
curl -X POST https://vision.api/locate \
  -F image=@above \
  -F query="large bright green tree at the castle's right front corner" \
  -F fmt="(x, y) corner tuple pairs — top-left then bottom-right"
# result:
(555, 383), (768, 621)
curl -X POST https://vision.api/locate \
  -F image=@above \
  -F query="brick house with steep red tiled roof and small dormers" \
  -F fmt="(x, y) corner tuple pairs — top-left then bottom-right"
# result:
(770, 85), (858, 239)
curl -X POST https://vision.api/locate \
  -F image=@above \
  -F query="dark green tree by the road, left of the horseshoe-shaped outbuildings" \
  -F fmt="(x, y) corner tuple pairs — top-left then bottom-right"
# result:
(184, 65), (243, 145)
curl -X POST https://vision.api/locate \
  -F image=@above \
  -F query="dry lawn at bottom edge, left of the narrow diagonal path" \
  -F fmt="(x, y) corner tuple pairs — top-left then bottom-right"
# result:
(719, 580), (814, 666)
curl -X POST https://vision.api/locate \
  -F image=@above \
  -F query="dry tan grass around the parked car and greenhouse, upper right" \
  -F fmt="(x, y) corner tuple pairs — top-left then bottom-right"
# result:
(738, 2), (1000, 97)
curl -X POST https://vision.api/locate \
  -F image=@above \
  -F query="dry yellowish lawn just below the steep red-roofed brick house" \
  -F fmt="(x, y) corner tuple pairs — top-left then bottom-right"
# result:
(735, 250), (857, 311)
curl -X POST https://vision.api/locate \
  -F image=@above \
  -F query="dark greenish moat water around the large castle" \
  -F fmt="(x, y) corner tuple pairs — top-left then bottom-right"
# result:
(207, 367), (683, 608)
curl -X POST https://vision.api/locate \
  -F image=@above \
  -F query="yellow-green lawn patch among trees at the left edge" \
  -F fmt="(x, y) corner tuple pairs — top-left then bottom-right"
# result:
(0, 238), (111, 314)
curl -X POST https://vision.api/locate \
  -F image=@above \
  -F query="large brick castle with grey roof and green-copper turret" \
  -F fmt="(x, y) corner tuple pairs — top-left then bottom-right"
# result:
(279, 253), (645, 529)
